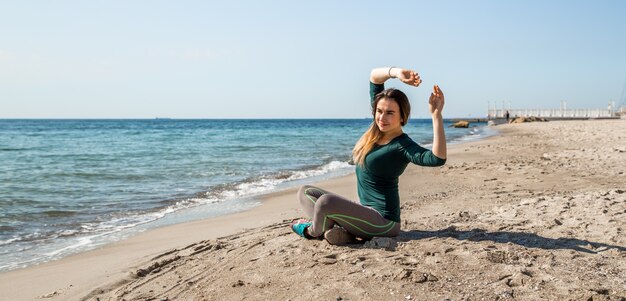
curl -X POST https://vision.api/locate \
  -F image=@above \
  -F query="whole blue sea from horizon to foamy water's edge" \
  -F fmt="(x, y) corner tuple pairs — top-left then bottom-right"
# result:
(0, 118), (495, 272)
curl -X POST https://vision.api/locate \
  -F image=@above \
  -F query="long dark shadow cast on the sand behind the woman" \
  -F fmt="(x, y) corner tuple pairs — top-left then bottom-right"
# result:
(396, 227), (626, 254)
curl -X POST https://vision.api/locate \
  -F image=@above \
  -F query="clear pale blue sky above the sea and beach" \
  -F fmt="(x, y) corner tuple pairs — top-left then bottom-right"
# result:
(0, 1), (626, 118)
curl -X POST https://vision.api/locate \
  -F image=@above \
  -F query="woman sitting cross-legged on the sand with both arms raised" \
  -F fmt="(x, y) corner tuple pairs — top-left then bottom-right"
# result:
(291, 67), (447, 244)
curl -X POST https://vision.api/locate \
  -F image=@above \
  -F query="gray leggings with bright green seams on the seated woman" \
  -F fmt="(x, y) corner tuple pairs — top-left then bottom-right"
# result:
(298, 185), (400, 239)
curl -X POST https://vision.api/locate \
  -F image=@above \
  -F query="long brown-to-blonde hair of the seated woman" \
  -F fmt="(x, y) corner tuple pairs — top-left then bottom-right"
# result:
(352, 88), (411, 166)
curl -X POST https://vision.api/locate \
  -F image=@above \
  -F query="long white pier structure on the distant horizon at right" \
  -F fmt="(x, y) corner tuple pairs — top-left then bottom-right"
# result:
(487, 101), (623, 119)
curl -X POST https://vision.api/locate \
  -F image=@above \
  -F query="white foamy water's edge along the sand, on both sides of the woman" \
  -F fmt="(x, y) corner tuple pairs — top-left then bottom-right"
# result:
(0, 120), (497, 273)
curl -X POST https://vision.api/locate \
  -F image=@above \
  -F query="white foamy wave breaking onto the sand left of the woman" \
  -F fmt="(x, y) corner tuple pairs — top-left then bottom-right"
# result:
(0, 161), (351, 270)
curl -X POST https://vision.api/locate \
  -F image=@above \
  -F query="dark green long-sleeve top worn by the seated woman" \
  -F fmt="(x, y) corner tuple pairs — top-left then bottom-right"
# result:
(356, 83), (446, 222)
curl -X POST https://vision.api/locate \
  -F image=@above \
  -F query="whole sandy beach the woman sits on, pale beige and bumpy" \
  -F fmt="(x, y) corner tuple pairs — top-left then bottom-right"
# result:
(0, 120), (626, 300)
